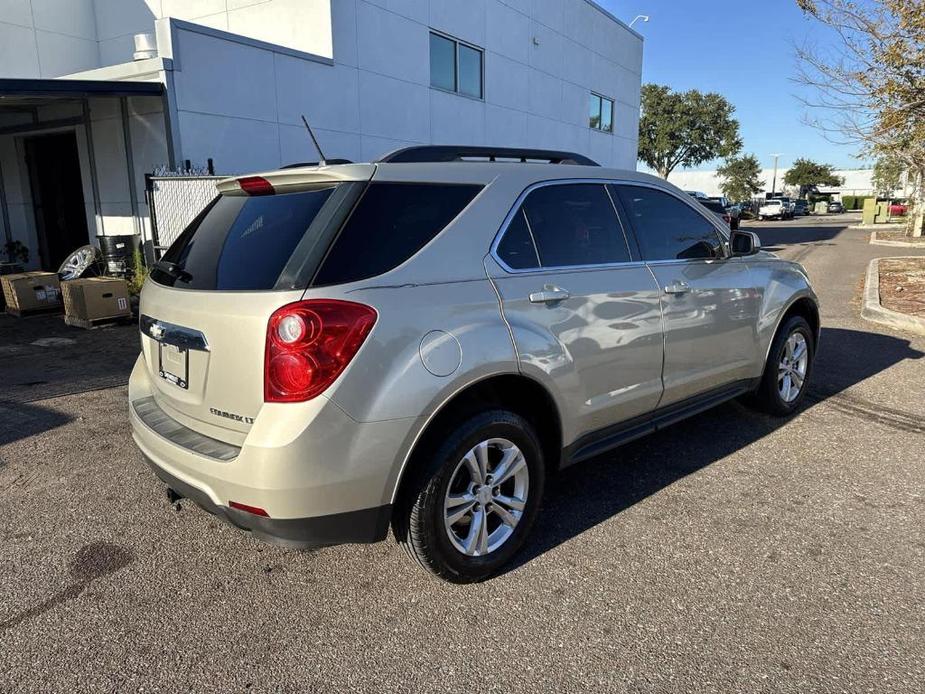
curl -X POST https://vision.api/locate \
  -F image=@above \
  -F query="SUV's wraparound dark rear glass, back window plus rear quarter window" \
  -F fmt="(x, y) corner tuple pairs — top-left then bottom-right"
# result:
(151, 183), (481, 291)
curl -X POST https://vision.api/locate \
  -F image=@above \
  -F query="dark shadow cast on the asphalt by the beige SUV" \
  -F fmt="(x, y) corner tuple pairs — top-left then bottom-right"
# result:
(507, 328), (925, 570)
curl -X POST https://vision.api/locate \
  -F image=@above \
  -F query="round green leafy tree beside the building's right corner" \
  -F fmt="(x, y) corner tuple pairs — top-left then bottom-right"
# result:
(639, 84), (742, 178)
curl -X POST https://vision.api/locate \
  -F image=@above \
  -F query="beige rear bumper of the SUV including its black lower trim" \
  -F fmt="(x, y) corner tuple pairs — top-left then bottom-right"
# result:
(128, 358), (417, 547)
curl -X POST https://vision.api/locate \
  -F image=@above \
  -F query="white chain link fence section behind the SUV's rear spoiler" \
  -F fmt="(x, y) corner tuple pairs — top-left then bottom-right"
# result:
(145, 175), (225, 258)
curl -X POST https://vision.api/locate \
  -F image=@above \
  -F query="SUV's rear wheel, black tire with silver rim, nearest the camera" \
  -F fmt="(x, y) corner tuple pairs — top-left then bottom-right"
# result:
(393, 409), (545, 583)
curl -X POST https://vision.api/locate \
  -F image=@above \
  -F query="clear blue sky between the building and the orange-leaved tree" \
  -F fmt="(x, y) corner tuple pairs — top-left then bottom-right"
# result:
(597, 0), (869, 169)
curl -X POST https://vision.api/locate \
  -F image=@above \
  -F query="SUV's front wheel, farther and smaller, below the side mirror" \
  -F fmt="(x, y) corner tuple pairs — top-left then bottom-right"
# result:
(748, 316), (816, 417)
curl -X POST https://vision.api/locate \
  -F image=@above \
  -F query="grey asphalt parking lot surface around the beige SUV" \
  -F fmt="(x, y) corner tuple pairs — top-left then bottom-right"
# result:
(0, 215), (925, 693)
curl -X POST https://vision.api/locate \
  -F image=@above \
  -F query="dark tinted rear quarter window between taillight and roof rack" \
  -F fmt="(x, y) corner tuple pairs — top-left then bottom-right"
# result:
(313, 183), (481, 285)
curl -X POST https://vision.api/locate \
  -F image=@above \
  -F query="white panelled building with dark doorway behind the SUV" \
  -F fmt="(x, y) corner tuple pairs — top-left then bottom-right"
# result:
(0, 0), (642, 268)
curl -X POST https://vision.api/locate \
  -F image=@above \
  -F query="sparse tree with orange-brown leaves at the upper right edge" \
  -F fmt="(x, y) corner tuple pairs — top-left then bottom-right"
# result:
(796, 0), (925, 236)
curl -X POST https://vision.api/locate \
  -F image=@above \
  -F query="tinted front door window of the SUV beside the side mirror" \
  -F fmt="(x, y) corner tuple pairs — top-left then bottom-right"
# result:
(614, 186), (722, 260)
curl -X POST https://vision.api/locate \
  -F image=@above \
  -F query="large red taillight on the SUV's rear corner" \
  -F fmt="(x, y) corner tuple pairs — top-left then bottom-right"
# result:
(263, 299), (376, 402)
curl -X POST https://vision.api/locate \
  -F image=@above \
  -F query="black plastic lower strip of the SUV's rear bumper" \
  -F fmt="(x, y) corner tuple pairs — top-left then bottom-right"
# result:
(145, 457), (392, 549)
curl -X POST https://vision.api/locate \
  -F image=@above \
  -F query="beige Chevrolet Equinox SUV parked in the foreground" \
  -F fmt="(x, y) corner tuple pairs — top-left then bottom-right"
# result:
(129, 147), (819, 582)
